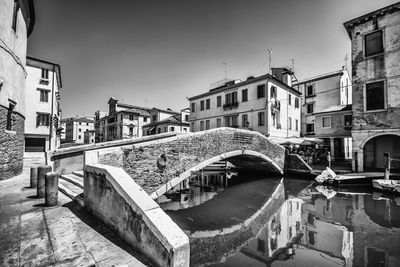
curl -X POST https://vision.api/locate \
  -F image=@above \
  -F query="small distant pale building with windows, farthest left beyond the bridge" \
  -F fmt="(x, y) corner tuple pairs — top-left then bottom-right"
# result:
(63, 117), (94, 144)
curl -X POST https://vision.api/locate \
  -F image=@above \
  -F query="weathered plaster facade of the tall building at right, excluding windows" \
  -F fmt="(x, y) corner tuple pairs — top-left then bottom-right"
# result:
(351, 8), (400, 171)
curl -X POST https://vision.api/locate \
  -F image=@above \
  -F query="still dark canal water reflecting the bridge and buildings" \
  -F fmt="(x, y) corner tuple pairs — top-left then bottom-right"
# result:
(161, 175), (400, 267)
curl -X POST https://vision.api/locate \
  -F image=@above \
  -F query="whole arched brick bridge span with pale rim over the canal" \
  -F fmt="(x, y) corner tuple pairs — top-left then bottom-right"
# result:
(85, 128), (285, 198)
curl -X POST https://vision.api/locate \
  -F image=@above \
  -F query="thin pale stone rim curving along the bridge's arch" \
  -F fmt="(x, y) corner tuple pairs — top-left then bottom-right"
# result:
(150, 149), (283, 199)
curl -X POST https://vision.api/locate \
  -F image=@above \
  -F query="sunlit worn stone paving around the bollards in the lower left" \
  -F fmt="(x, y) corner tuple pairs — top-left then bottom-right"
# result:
(0, 169), (148, 267)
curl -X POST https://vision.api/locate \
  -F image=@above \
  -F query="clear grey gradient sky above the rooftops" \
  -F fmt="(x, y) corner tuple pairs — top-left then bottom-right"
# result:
(28, 0), (397, 118)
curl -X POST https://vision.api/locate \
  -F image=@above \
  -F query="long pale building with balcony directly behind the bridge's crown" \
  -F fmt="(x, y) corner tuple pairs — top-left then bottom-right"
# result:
(189, 68), (301, 137)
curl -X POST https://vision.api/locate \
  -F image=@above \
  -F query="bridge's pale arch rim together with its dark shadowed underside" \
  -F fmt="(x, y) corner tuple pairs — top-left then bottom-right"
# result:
(150, 150), (283, 199)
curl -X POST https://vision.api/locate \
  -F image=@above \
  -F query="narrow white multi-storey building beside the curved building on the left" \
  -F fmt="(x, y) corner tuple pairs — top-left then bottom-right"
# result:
(25, 57), (62, 153)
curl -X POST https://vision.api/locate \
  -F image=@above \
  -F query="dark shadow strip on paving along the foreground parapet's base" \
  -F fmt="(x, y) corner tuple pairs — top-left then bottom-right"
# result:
(62, 202), (151, 266)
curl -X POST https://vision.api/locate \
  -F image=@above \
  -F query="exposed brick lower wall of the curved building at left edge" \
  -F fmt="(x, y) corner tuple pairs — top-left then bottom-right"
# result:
(0, 106), (25, 180)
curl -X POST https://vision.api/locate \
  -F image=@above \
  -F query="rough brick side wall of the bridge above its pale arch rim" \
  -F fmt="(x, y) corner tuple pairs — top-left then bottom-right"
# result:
(119, 128), (285, 193)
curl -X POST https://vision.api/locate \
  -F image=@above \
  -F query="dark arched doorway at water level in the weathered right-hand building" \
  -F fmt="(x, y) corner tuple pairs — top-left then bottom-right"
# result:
(364, 134), (400, 171)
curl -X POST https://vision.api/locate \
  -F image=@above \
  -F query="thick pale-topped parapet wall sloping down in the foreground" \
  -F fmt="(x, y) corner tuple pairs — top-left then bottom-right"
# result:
(84, 165), (190, 266)
